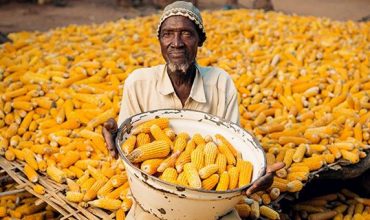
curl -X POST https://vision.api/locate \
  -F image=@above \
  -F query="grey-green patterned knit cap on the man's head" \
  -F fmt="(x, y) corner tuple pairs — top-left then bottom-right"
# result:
(157, 1), (206, 43)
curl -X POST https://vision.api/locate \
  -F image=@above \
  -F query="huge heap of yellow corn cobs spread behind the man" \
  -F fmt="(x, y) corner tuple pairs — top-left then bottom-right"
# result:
(0, 7), (370, 218)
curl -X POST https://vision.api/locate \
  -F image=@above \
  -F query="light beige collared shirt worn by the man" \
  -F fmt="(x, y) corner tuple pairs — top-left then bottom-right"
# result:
(118, 65), (239, 125)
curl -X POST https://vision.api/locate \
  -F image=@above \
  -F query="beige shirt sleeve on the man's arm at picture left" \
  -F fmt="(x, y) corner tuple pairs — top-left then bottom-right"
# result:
(118, 83), (142, 126)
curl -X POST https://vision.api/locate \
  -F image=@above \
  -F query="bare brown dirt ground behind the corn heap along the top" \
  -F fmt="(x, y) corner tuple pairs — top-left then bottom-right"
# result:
(0, 0), (370, 33)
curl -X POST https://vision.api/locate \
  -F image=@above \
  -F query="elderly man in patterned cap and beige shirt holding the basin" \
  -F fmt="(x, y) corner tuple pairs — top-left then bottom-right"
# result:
(103, 1), (284, 219)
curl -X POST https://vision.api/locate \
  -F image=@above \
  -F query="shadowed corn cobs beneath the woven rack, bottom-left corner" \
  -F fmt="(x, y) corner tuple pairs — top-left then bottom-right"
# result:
(0, 183), (58, 220)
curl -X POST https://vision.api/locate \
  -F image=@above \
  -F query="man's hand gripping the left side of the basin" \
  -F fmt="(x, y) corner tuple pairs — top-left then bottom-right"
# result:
(102, 118), (118, 158)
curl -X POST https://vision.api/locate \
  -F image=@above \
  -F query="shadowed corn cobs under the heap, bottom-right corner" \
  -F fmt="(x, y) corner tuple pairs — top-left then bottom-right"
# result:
(284, 188), (370, 220)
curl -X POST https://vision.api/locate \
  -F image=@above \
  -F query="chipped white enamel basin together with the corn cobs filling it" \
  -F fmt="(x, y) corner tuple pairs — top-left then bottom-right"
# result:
(116, 109), (266, 219)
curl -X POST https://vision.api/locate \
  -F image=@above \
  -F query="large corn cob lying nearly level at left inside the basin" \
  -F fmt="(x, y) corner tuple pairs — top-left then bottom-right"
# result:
(127, 141), (170, 163)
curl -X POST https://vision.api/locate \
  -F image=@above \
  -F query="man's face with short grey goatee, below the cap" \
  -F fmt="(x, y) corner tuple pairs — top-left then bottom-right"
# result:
(159, 16), (199, 73)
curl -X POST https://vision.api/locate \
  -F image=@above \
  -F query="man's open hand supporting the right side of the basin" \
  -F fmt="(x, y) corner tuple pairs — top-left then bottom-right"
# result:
(245, 162), (285, 196)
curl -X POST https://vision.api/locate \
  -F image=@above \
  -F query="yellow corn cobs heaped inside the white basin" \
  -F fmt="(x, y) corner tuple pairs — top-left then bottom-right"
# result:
(121, 118), (253, 191)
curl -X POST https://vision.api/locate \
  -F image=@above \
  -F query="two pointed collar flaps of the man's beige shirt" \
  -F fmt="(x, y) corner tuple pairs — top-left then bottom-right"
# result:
(158, 64), (207, 103)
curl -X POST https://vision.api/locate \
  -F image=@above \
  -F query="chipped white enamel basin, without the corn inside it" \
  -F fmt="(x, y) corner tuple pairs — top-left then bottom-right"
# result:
(116, 109), (266, 220)
